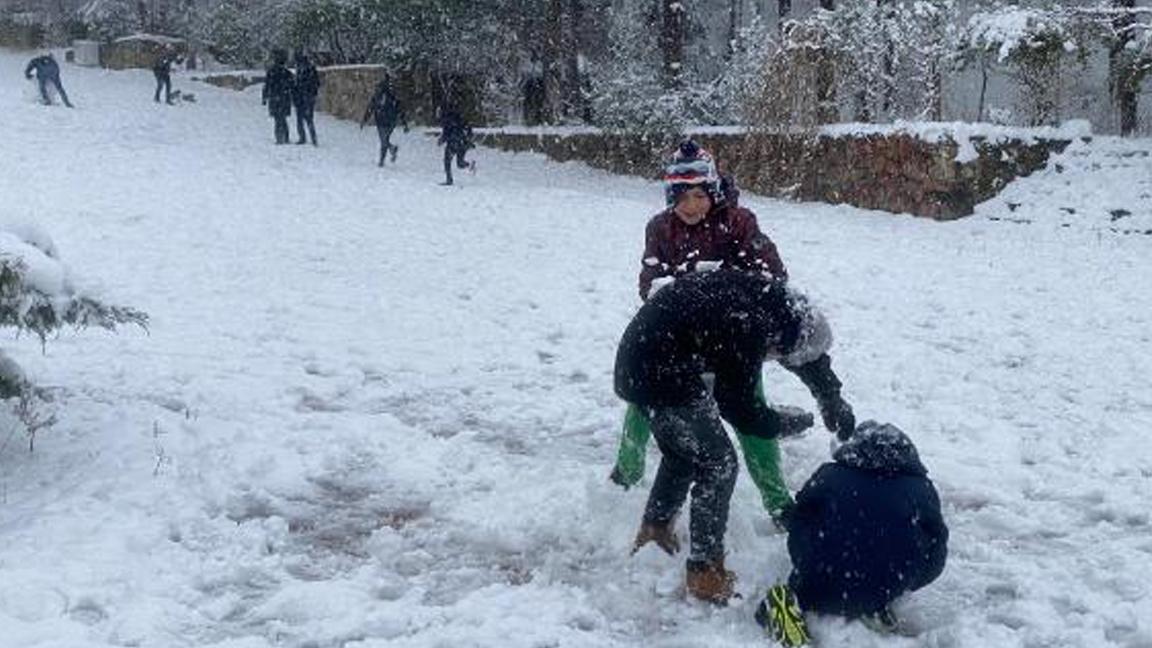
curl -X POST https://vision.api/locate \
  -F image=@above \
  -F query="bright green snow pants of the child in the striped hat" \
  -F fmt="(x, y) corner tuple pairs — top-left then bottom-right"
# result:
(612, 382), (793, 515)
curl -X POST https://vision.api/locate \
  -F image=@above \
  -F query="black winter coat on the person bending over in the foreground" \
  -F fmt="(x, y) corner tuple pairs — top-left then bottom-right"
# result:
(615, 265), (801, 437)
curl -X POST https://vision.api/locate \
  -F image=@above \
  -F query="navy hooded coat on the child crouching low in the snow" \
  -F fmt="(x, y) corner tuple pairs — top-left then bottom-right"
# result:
(788, 421), (948, 617)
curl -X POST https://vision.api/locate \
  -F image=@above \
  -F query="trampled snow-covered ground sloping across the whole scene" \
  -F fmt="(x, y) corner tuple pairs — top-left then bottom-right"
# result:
(0, 52), (1152, 648)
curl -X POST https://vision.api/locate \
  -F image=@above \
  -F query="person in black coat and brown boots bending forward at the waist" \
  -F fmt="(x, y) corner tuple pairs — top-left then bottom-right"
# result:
(615, 269), (855, 603)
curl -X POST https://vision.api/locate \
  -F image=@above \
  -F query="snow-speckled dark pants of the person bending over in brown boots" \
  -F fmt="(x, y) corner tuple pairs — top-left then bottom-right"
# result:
(644, 398), (737, 562)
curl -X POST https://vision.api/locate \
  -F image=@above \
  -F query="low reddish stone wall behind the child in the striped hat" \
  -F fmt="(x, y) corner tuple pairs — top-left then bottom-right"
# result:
(477, 131), (1069, 220)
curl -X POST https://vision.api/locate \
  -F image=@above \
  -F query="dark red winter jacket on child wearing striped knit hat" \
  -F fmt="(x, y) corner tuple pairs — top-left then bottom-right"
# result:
(639, 204), (788, 300)
